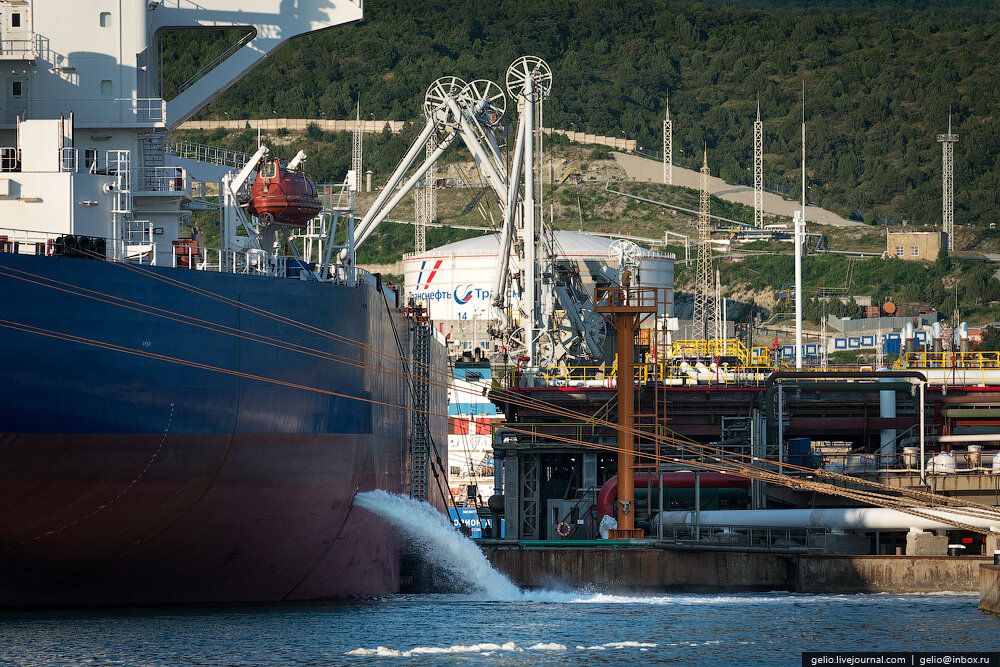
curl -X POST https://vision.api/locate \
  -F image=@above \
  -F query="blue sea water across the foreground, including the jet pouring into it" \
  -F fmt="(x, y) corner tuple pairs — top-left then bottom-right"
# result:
(0, 492), (1000, 665)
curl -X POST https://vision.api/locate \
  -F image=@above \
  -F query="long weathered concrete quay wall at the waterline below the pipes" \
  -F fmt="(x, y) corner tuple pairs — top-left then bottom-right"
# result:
(482, 542), (996, 593)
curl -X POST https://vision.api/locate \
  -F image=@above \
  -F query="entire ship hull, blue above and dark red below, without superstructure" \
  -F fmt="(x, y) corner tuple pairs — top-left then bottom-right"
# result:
(0, 253), (445, 606)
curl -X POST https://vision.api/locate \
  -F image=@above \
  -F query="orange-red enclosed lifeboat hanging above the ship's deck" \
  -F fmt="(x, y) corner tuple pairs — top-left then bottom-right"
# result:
(250, 158), (323, 227)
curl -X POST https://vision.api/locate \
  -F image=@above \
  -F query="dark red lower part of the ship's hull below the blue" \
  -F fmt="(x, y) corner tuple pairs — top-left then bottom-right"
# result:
(0, 434), (405, 606)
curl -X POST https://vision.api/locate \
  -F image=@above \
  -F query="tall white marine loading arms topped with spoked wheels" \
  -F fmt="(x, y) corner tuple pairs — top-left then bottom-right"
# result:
(338, 56), (605, 366)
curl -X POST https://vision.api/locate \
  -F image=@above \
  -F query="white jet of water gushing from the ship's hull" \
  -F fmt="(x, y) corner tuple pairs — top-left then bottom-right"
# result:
(354, 490), (524, 600)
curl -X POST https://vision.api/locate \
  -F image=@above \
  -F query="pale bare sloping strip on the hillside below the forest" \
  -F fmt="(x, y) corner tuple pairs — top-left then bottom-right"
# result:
(613, 152), (864, 227)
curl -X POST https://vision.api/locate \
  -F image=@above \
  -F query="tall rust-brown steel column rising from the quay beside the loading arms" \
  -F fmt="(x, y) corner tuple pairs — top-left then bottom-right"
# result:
(615, 312), (635, 530)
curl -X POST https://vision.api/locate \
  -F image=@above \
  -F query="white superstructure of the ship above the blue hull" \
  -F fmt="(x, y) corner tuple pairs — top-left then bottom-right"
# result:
(0, 0), (362, 266)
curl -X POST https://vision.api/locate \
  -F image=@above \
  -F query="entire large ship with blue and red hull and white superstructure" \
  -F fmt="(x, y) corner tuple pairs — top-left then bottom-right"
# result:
(0, 0), (446, 606)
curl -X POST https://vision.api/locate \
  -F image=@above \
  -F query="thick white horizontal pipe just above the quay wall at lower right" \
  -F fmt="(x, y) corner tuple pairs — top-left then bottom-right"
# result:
(655, 507), (1000, 532)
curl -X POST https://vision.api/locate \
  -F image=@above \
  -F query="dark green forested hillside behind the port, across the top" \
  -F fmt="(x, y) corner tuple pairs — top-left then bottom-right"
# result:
(164, 0), (1000, 226)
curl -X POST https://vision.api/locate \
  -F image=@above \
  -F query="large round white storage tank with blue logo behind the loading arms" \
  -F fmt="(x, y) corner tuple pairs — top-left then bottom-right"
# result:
(403, 231), (674, 323)
